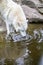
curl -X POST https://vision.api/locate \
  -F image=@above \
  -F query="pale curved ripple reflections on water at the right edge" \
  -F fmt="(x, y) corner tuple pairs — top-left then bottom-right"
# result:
(33, 28), (43, 43)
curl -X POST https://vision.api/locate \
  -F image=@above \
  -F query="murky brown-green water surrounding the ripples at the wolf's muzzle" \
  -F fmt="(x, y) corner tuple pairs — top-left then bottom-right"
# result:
(0, 24), (43, 65)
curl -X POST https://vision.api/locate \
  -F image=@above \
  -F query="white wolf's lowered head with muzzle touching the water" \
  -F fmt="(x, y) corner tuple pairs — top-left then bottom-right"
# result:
(13, 17), (28, 37)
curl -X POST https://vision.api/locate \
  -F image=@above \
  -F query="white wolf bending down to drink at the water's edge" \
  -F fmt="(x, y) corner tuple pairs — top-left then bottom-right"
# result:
(0, 0), (28, 36)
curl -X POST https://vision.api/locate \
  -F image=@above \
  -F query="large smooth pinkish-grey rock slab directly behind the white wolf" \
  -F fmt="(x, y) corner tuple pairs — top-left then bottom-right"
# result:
(22, 5), (43, 22)
